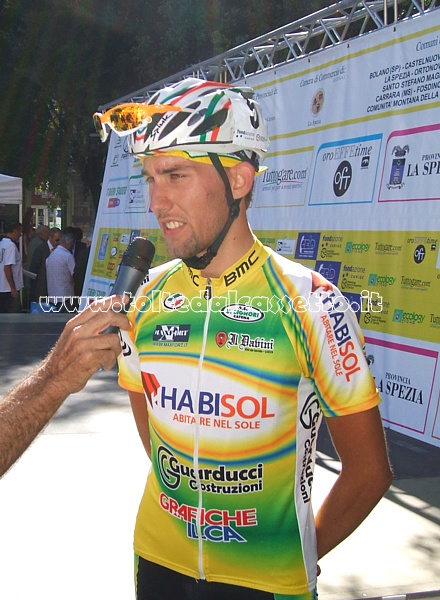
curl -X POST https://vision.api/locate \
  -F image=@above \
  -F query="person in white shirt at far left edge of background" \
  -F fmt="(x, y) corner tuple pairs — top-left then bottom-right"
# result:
(0, 222), (23, 313)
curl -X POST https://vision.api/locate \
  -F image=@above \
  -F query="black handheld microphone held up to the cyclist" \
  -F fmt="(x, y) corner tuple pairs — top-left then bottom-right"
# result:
(101, 237), (156, 333)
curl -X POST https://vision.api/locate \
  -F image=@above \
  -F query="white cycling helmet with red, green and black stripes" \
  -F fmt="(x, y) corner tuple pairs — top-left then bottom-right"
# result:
(95, 78), (269, 166)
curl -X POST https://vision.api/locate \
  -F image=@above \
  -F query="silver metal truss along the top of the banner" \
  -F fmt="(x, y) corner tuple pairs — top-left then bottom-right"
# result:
(100, 0), (440, 110)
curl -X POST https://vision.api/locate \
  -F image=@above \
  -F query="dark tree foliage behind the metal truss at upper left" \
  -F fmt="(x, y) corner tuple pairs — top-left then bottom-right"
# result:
(0, 0), (332, 202)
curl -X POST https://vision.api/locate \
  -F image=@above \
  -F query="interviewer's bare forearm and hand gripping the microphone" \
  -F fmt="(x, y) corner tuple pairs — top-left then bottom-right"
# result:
(0, 296), (130, 477)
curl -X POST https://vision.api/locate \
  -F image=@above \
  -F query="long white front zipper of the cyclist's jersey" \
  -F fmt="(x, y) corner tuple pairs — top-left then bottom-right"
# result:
(193, 278), (212, 579)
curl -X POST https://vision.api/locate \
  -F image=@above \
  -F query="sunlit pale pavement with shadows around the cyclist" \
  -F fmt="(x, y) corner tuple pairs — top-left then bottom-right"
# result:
(0, 314), (440, 600)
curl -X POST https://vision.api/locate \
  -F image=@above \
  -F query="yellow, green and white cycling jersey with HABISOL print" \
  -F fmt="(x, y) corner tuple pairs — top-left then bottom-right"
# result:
(119, 240), (380, 594)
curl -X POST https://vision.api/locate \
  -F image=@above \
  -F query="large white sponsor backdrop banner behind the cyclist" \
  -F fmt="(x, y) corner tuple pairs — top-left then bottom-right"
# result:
(84, 10), (440, 446)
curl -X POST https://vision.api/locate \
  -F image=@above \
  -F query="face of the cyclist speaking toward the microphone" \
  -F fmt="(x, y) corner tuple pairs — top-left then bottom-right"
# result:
(144, 156), (228, 258)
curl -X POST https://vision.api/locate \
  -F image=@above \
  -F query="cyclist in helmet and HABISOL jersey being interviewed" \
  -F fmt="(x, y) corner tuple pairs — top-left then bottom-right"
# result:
(96, 79), (391, 600)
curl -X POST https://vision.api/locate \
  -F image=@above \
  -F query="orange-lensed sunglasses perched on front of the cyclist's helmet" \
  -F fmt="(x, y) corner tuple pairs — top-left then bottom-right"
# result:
(93, 103), (182, 142)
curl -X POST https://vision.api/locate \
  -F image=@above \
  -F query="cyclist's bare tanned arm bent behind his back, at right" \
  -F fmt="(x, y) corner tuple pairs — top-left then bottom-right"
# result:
(315, 408), (392, 558)
